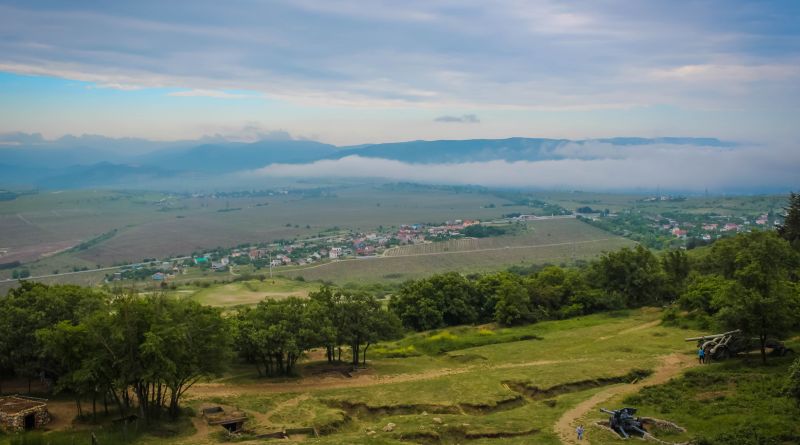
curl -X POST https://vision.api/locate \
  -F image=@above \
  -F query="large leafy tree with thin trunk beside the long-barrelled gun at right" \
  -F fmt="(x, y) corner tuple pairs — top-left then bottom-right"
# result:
(714, 232), (800, 363)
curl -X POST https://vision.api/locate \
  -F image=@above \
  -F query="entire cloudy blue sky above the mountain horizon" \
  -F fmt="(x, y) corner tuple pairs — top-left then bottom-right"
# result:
(0, 0), (800, 147)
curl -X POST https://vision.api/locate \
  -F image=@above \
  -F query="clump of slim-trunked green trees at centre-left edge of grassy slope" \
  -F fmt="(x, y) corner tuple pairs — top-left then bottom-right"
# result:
(232, 287), (402, 376)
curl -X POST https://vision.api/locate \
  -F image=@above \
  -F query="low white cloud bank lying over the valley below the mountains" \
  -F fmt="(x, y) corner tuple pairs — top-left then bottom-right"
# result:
(253, 143), (800, 192)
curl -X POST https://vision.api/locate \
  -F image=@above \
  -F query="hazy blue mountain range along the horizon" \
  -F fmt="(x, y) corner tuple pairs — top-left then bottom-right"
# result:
(0, 133), (735, 189)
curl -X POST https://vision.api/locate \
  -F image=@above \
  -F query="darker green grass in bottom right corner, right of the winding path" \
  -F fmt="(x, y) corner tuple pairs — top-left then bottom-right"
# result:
(586, 345), (800, 445)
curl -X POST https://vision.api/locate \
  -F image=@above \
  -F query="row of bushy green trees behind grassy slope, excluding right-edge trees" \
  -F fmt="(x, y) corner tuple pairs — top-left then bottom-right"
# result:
(389, 246), (689, 331)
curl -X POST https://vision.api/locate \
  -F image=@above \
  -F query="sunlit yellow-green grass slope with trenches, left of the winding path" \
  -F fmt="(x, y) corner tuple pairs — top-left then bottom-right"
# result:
(177, 310), (691, 444)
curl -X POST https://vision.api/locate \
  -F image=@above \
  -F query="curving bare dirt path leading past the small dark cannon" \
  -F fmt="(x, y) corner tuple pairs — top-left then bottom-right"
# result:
(554, 352), (697, 445)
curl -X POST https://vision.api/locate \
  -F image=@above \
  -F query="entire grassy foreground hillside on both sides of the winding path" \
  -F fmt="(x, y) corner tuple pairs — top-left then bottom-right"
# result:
(17, 309), (800, 445)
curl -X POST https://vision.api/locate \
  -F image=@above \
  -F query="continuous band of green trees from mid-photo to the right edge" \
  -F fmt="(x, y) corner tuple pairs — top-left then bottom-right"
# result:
(389, 224), (800, 361)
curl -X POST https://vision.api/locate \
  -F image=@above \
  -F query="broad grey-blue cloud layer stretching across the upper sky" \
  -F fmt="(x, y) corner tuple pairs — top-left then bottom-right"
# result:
(0, 0), (800, 110)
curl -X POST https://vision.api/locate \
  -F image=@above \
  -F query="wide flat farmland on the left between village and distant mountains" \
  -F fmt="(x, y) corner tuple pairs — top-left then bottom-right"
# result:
(0, 185), (536, 278)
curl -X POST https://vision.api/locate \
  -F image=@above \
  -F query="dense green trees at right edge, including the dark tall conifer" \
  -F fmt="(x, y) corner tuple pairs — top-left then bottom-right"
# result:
(666, 193), (800, 362)
